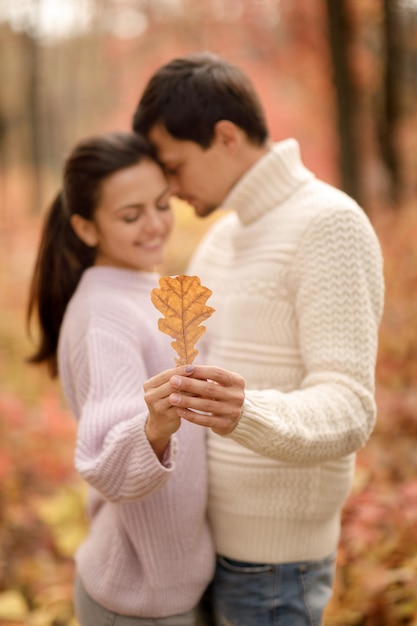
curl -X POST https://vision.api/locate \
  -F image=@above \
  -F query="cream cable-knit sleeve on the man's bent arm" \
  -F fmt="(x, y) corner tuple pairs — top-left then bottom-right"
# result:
(228, 209), (383, 464)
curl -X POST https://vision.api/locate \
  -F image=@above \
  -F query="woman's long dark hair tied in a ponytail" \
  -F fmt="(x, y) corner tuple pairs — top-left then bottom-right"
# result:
(27, 132), (154, 377)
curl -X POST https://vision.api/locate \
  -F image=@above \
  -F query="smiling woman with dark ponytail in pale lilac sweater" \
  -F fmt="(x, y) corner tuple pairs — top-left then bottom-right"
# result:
(28, 133), (214, 626)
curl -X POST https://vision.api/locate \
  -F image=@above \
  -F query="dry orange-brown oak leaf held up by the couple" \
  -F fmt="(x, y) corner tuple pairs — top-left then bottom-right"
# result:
(151, 274), (215, 365)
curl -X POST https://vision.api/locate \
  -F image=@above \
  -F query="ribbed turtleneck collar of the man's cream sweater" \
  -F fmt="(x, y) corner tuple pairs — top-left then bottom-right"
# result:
(222, 139), (314, 224)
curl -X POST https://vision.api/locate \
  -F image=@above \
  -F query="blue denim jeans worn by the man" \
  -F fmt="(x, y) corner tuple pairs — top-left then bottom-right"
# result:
(212, 555), (335, 626)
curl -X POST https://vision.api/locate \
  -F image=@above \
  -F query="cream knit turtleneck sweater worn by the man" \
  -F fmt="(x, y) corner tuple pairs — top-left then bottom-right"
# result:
(189, 139), (383, 563)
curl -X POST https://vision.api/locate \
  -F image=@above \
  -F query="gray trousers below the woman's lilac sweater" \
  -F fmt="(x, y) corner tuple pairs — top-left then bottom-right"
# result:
(74, 576), (197, 626)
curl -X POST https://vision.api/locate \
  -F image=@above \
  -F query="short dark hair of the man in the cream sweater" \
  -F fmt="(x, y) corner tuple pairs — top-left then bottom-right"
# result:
(132, 52), (268, 148)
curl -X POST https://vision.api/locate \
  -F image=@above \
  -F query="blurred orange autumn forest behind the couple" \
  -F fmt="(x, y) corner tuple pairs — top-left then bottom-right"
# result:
(0, 0), (417, 626)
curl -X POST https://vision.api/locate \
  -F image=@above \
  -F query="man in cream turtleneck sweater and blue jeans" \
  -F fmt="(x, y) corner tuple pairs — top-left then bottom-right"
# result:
(133, 53), (383, 626)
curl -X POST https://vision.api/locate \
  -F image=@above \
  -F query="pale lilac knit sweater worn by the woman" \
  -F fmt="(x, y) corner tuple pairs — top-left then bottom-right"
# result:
(58, 267), (214, 617)
